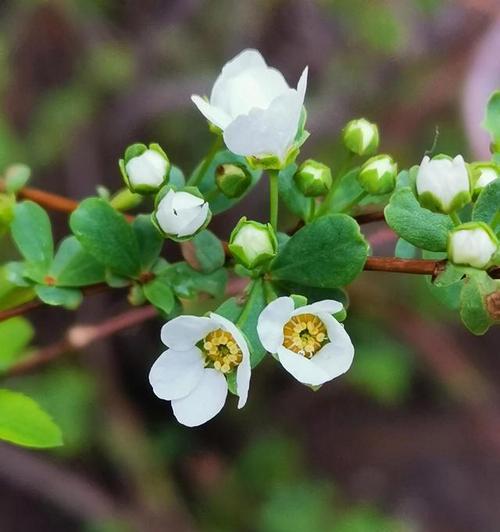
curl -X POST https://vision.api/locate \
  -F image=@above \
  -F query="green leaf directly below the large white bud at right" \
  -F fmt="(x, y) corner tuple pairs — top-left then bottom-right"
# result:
(384, 188), (453, 251)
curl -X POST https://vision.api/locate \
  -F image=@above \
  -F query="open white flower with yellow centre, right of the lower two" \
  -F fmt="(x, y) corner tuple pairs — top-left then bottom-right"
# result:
(257, 297), (354, 386)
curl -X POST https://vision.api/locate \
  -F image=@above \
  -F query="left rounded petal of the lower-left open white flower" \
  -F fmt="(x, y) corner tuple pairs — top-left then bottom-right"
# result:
(149, 347), (204, 401)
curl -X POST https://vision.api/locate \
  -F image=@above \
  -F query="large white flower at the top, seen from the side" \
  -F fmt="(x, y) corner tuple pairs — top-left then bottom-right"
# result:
(191, 50), (307, 160)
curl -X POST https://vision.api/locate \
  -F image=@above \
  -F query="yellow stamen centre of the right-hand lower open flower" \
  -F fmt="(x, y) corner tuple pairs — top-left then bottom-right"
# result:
(283, 314), (328, 358)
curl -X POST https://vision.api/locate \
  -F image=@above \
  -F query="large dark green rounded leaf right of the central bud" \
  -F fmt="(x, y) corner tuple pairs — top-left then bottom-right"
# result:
(272, 214), (368, 288)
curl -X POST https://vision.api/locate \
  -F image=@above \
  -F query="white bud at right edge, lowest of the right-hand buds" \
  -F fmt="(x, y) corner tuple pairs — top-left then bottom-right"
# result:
(448, 222), (498, 269)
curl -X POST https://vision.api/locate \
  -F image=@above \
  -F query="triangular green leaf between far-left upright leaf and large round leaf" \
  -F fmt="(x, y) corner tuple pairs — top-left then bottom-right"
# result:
(48, 236), (104, 287)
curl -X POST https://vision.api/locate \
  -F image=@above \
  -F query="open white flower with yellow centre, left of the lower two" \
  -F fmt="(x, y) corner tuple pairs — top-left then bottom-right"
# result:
(149, 313), (251, 427)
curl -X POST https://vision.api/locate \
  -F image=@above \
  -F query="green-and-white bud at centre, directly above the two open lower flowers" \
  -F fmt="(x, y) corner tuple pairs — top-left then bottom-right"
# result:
(228, 217), (278, 269)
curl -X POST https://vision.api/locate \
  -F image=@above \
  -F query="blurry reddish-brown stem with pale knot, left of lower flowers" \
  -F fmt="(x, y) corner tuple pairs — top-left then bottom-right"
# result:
(4, 305), (158, 377)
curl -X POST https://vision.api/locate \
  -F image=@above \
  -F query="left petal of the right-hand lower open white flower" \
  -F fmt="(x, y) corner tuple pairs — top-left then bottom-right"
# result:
(257, 297), (294, 353)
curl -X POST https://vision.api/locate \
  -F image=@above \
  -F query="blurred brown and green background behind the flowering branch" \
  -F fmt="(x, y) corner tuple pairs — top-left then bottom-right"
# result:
(0, 0), (500, 532)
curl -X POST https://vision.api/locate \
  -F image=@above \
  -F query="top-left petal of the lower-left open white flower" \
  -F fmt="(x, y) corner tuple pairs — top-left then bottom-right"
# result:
(161, 316), (217, 351)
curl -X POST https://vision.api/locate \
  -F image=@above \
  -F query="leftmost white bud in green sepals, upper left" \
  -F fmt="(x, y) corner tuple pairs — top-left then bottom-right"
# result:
(118, 144), (170, 194)
